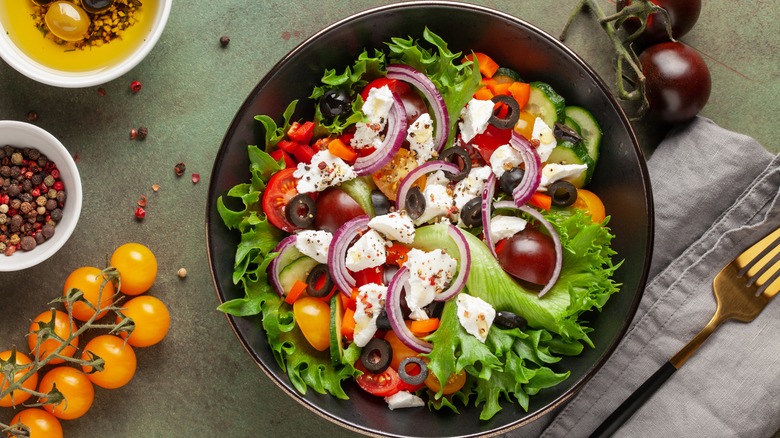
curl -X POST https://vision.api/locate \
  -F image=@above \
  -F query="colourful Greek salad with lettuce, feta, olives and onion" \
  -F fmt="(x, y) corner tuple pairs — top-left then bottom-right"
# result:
(217, 29), (620, 420)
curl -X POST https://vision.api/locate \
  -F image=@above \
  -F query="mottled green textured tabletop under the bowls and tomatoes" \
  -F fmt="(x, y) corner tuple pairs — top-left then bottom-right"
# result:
(0, 0), (780, 437)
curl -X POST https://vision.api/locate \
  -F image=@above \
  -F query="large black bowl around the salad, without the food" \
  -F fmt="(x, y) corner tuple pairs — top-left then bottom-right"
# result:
(206, 2), (653, 436)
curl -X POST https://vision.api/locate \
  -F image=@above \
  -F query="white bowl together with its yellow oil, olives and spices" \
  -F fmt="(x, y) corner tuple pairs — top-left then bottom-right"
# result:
(0, 0), (172, 88)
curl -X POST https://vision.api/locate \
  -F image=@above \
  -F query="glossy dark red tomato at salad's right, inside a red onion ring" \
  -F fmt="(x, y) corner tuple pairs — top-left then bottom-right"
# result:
(496, 227), (555, 284)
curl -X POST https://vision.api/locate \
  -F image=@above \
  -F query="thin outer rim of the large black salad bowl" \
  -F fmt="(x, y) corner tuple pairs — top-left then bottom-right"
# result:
(205, 1), (655, 437)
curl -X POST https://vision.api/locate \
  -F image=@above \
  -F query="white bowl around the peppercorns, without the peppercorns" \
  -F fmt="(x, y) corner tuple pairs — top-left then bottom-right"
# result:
(0, 120), (82, 272)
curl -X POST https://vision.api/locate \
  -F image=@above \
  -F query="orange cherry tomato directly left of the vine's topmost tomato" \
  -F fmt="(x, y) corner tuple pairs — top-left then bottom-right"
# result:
(62, 266), (115, 321)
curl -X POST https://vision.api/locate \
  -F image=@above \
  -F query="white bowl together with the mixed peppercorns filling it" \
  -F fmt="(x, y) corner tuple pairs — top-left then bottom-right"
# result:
(0, 120), (82, 272)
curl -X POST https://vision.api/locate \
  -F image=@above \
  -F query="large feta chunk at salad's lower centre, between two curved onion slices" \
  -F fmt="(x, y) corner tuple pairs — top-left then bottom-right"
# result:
(404, 248), (458, 320)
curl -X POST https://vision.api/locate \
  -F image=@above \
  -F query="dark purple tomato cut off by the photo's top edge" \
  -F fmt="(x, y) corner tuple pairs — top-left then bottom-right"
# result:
(616, 0), (701, 47)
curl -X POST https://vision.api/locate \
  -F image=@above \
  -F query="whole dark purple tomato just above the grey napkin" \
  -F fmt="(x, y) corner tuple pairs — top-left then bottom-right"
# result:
(639, 42), (712, 123)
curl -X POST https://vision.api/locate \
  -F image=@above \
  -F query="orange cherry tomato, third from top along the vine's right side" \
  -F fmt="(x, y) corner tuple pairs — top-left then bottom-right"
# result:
(81, 335), (137, 389)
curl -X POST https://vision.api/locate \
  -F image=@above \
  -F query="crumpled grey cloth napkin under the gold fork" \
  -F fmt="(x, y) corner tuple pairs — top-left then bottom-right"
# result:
(521, 117), (780, 437)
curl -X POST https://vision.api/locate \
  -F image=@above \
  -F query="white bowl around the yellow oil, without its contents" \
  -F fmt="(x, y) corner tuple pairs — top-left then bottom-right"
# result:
(0, 0), (173, 88)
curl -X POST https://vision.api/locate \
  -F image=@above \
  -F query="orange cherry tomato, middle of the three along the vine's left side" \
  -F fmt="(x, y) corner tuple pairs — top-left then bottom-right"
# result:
(27, 310), (79, 364)
